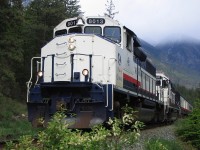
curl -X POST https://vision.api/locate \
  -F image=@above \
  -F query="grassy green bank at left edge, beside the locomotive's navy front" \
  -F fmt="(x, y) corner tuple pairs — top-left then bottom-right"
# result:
(0, 94), (35, 141)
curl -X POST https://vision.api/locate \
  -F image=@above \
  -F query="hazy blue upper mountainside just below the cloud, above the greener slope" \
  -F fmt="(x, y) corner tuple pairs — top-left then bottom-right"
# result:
(156, 40), (200, 72)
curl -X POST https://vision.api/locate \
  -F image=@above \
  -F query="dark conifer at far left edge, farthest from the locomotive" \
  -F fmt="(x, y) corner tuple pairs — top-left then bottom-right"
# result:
(0, 0), (23, 97)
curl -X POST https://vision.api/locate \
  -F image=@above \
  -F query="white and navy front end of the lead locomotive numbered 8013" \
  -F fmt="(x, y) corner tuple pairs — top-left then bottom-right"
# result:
(27, 17), (130, 128)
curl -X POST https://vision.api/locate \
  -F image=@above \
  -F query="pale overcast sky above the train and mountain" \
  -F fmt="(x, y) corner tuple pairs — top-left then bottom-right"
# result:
(79, 0), (200, 44)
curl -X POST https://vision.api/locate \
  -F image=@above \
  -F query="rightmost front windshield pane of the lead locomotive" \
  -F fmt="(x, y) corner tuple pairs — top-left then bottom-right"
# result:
(104, 26), (121, 43)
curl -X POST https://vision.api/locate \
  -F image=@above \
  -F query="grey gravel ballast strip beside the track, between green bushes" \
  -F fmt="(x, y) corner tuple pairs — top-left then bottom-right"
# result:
(130, 125), (176, 150)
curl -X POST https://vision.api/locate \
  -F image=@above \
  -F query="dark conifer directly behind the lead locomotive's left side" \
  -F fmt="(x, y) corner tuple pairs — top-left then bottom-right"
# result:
(23, 0), (80, 98)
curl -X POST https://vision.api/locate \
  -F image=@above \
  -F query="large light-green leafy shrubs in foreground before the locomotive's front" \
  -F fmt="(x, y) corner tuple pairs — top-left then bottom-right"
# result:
(7, 106), (143, 150)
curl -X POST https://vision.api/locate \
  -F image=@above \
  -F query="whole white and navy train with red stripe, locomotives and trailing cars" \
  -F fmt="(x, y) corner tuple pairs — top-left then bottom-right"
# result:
(27, 16), (192, 128)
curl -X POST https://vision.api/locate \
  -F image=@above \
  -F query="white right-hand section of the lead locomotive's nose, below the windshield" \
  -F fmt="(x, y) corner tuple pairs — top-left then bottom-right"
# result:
(92, 36), (117, 85)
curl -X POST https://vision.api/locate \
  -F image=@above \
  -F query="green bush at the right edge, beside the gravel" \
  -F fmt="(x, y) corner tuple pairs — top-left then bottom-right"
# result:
(176, 99), (200, 149)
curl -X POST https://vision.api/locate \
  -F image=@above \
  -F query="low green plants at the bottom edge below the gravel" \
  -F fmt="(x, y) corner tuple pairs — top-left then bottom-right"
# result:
(145, 139), (182, 150)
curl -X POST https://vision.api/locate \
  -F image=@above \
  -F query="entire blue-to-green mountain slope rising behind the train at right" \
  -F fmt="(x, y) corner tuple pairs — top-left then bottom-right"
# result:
(141, 40), (200, 88)
